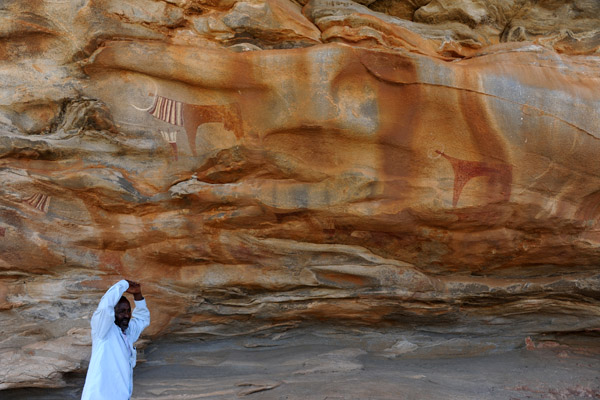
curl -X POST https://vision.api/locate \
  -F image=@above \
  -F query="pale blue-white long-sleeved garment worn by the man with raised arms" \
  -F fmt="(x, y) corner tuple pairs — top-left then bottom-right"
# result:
(81, 280), (150, 400)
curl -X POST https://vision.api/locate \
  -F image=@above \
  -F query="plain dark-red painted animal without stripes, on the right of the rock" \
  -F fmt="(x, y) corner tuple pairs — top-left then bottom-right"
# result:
(436, 150), (512, 207)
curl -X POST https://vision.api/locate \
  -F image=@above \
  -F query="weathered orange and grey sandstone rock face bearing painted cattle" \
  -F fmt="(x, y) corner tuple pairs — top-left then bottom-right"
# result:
(0, 0), (600, 389)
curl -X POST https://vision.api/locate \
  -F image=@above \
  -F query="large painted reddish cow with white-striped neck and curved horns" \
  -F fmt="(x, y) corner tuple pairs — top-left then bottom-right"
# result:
(132, 88), (244, 155)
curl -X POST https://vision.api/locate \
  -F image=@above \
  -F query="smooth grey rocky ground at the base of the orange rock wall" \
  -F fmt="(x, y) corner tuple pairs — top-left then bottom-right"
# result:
(0, 331), (600, 400)
